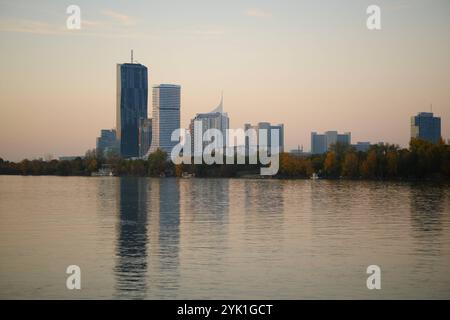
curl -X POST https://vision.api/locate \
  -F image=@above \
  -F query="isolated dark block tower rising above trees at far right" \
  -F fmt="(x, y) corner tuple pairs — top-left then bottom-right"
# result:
(411, 112), (441, 143)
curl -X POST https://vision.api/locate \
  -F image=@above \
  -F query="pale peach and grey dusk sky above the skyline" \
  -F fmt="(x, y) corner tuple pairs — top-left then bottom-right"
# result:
(0, 0), (450, 161)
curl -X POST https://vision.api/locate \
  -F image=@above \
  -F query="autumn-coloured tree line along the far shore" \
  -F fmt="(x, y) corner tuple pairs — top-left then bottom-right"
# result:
(0, 139), (450, 180)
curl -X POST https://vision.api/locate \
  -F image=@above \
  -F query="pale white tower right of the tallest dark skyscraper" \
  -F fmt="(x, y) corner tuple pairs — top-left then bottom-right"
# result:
(148, 84), (181, 156)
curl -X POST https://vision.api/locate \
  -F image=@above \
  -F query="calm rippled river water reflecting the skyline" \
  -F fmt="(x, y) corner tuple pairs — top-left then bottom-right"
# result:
(0, 176), (450, 299)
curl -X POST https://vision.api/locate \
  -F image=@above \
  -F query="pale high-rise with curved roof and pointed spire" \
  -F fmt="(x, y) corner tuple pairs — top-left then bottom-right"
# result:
(189, 96), (230, 153)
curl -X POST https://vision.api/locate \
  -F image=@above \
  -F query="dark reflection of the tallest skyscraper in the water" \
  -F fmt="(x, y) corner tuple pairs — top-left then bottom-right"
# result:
(114, 177), (148, 298)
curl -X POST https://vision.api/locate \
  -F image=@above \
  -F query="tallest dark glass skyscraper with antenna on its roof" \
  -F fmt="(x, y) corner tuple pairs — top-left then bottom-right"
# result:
(116, 63), (148, 158)
